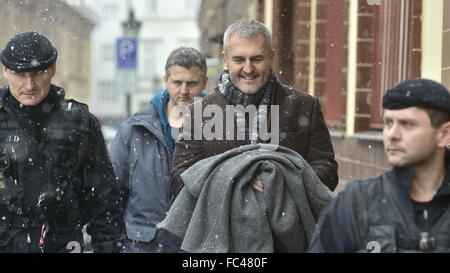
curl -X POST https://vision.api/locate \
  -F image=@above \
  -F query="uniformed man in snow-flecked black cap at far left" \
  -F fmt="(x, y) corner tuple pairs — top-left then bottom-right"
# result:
(0, 31), (124, 253)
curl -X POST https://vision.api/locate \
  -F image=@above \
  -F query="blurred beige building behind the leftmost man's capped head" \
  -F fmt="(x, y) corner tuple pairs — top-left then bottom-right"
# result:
(0, 0), (93, 103)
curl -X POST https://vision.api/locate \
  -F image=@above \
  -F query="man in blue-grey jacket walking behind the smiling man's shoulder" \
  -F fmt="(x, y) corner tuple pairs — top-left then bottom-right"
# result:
(110, 47), (208, 252)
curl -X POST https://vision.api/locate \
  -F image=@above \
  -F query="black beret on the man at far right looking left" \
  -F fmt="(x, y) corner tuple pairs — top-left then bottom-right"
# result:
(383, 78), (450, 115)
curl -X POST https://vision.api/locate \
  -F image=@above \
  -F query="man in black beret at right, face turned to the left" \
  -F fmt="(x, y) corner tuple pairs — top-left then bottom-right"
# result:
(309, 79), (450, 252)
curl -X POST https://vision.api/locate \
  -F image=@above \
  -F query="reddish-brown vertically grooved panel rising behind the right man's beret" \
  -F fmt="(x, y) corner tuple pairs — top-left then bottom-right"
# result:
(370, 0), (422, 128)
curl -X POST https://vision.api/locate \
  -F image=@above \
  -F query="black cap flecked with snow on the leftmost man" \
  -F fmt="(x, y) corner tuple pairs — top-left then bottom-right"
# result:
(0, 31), (58, 72)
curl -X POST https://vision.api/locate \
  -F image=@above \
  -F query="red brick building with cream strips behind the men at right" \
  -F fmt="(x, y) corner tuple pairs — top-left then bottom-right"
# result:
(199, 0), (450, 190)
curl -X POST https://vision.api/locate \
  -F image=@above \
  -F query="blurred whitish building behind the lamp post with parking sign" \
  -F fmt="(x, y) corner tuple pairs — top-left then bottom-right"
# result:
(85, 0), (200, 125)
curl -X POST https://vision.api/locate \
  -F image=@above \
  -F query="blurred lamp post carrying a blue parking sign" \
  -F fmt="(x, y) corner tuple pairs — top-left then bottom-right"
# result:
(116, 1), (141, 116)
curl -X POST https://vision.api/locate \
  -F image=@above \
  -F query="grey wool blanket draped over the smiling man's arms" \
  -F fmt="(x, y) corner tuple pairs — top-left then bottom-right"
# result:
(158, 144), (333, 253)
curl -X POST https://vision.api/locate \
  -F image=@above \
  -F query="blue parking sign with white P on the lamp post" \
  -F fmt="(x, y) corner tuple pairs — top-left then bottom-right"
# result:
(116, 38), (137, 69)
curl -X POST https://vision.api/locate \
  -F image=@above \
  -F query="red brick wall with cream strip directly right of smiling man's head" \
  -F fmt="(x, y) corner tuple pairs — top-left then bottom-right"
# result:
(272, 0), (348, 129)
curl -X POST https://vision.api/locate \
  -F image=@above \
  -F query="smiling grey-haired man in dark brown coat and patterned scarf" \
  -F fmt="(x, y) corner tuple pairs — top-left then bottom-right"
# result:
(170, 19), (338, 202)
